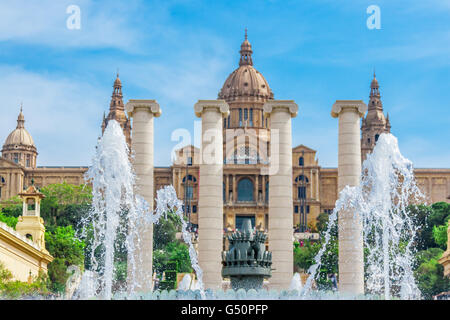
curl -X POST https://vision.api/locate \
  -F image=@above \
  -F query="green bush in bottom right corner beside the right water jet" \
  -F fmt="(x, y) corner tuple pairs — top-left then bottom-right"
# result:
(414, 248), (450, 299)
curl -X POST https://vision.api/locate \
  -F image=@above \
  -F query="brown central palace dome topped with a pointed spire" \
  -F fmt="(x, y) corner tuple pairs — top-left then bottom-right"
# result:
(219, 33), (273, 102)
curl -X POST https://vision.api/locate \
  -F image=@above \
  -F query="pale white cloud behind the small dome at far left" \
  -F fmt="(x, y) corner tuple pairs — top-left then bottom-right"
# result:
(0, 65), (105, 166)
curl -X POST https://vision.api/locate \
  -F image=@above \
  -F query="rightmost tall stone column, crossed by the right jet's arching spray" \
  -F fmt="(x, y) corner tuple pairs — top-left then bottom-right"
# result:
(331, 100), (367, 294)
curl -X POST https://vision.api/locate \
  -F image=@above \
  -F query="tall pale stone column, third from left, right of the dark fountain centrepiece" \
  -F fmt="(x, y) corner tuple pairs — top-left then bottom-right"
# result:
(264, 100), (298, 290)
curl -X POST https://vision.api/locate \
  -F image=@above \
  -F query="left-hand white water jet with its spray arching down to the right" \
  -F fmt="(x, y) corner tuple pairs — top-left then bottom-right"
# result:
(76, 120), (204, 299)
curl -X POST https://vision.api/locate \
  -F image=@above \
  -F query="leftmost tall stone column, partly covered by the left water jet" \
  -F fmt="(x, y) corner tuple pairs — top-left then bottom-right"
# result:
(126, 100), (161, 292)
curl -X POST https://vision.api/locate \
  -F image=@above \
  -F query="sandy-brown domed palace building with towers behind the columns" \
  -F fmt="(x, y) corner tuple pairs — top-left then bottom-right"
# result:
(0, 35), (450, 231)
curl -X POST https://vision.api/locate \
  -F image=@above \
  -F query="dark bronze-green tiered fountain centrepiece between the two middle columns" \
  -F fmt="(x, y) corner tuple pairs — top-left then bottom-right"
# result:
(222, 219), (272, 290)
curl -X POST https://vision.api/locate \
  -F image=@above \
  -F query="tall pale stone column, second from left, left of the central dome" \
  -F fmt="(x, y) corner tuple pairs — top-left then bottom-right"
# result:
(194, 100), (229, 290)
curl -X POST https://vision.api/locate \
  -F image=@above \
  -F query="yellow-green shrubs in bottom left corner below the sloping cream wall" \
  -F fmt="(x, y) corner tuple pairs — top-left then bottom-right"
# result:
(0, 262), (49, 299)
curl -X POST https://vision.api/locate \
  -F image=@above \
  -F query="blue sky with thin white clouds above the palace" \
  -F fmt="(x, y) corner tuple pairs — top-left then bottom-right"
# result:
(0, 0), (450, 168)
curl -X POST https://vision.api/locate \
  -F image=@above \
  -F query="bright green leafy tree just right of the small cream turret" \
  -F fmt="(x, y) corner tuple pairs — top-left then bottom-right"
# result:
(45, 226), (85, 292)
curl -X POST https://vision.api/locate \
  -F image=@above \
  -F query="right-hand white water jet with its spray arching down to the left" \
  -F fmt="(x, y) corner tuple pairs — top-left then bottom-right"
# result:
(302, 133), (424, 299)
